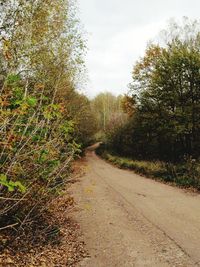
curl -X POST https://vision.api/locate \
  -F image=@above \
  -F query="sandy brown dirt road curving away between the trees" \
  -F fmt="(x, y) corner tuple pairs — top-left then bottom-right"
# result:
(72, 151), (200, 267)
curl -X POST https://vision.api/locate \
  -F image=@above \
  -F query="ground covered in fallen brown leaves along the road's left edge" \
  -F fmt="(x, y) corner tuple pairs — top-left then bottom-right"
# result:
(0, 168), (88, 267)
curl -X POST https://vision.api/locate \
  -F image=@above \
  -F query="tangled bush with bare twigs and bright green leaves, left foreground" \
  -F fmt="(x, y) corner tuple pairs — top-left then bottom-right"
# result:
(0, 74), (80, 246)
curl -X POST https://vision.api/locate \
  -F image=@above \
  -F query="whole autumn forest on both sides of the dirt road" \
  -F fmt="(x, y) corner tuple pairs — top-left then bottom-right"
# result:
(0, 0), (200, 266)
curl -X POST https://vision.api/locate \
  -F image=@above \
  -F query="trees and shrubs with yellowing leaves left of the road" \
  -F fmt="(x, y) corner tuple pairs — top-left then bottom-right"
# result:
(0, 0), (96, 244)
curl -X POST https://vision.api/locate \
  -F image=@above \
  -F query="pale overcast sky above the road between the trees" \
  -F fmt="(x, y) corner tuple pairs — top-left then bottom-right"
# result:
(78, 0), (200, 97)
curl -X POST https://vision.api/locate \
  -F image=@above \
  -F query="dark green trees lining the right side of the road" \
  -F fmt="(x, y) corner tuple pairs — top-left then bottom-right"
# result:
(109, 18), (200, 162)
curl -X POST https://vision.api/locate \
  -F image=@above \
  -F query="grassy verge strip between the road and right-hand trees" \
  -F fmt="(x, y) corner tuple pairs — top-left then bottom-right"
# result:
(96, 148), (200, 191)
